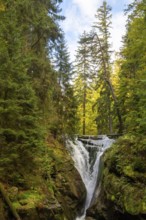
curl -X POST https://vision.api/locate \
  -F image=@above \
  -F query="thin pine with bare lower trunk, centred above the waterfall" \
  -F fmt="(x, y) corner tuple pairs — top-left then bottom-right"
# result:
(75, 32), (91, 135)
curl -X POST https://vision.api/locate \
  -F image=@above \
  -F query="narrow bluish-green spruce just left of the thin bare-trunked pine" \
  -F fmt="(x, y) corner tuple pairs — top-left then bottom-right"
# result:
(55, 33), (76, 135)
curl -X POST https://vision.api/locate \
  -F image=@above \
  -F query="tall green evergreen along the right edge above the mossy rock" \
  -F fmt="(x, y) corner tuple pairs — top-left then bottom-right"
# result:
(119, 0), (146, 134)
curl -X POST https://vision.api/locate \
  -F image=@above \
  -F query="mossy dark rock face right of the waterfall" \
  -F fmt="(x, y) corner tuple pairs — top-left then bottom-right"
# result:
(88, 137), (146, 220)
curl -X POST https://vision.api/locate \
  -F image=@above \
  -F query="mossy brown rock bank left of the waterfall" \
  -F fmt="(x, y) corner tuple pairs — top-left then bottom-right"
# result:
(0, 140), (86, 220)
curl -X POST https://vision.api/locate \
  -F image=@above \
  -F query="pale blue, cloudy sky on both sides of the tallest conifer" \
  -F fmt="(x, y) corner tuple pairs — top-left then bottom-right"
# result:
(61, 0), (132, 61)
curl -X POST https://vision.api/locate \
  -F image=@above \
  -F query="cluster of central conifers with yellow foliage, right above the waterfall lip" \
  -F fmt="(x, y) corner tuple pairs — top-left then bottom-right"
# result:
(74, 1), (122, 134)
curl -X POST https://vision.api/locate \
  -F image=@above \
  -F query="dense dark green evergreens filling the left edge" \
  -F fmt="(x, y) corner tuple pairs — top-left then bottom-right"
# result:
(0, 0), (63, 180)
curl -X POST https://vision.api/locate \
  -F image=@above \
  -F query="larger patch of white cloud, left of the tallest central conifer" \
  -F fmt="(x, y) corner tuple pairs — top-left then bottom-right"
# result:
(61, 0), (101, 60)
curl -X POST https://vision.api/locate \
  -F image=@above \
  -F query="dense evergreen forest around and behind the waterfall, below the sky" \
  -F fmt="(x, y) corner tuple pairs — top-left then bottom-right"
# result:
(0, 0), (146, 220)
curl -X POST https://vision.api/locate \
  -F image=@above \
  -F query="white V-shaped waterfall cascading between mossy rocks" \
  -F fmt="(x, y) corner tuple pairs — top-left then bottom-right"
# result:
(67, 135), (114, 220)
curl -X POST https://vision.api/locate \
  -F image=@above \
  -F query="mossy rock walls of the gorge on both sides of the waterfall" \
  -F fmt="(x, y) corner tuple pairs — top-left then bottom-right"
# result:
(0, 136), (146, 220)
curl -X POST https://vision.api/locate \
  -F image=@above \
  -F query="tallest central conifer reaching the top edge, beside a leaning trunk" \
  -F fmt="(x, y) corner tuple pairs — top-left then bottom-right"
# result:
(92, 1), (122, 133)
